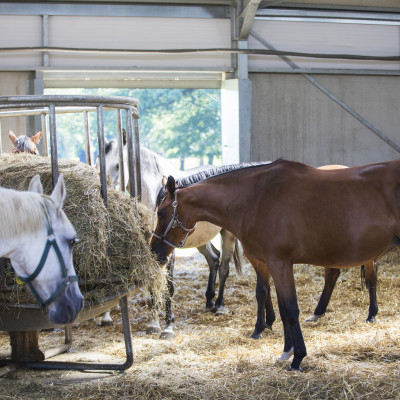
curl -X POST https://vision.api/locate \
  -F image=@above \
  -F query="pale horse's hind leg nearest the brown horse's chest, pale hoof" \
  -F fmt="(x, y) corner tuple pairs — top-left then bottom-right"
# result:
(215, 229), (236, 315)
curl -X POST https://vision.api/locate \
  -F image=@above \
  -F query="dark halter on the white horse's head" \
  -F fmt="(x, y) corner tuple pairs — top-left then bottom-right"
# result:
(13, 204), (78, 308)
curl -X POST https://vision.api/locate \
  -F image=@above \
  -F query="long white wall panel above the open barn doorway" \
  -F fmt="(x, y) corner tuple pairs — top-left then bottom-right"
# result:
(49, 16), (230, 67)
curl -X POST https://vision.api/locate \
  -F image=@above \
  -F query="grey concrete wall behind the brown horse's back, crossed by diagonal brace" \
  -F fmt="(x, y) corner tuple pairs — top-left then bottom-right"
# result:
(250, 73), (400, 166)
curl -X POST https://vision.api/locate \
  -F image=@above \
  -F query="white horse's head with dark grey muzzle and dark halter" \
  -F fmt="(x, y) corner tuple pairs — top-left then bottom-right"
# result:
(7, 175), (83, 324)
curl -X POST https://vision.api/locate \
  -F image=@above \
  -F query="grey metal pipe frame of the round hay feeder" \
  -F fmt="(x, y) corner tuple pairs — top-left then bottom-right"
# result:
(0, 95), (141, 370)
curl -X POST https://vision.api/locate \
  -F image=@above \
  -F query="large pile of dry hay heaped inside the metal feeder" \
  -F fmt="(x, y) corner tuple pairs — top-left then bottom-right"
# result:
(0, 154), (166, 304)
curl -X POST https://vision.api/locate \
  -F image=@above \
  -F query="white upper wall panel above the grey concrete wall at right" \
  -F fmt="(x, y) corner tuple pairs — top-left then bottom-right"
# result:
(249, 20), (400, 70)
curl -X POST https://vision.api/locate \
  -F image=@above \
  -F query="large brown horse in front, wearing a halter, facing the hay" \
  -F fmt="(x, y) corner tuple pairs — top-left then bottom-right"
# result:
(151, 160), (400, 370)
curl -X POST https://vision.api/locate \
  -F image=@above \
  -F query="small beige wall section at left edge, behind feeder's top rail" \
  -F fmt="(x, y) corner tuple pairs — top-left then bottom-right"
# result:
(0, 72), (34, 153)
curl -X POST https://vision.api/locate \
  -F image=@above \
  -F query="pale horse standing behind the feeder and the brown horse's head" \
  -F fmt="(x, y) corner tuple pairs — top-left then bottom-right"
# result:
(96, 137), (241, 338)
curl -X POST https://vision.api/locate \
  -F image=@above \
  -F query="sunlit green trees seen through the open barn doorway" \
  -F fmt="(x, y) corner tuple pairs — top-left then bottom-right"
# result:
(45, 89), (221, 168)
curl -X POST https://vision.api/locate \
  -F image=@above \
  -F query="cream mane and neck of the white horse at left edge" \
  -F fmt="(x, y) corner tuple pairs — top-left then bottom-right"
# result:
(0, 187), (46, 239)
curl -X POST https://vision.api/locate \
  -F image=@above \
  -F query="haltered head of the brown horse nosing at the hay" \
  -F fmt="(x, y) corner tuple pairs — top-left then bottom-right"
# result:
(150, 176), (196, 264)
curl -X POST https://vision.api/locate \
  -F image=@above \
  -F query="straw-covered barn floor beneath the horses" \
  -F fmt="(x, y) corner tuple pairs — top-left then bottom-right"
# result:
(0, 251), (400, 400)
